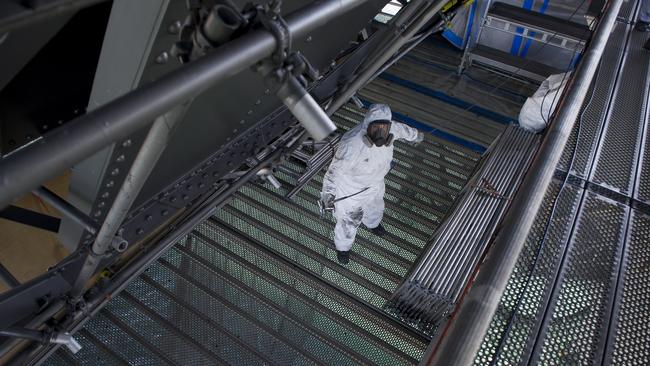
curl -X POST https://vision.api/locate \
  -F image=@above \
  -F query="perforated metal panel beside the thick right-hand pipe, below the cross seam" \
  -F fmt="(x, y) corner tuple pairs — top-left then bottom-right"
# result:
(476, 182), (582, 365)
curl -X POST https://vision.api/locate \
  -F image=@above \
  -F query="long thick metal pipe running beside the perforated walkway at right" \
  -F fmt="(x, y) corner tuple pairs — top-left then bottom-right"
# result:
(421, 0), (623, 365)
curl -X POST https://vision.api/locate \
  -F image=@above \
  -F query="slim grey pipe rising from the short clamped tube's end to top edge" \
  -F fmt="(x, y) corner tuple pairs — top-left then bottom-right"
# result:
(326, 0), (447, 116)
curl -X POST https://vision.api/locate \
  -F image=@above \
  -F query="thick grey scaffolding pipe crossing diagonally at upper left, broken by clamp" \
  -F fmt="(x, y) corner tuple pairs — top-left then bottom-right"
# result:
(0, 0), (368, 208)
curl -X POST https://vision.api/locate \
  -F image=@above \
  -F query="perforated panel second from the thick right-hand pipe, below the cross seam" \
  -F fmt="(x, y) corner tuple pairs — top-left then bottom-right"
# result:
(532, 192), (628, 365)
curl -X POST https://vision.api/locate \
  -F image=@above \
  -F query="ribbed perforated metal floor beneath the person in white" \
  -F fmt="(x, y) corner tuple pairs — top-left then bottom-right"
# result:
(41, 106), (478, 365)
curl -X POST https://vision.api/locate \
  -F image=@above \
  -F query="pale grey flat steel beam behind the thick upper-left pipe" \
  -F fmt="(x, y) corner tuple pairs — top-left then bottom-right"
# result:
(58, 0), (168, 252)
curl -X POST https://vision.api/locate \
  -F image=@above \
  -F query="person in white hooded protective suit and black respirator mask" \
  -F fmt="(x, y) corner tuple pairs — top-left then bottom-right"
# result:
(320, 104), (424, 264)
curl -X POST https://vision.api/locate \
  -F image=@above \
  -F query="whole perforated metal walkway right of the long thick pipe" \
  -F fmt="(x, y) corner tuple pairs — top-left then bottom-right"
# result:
(475, 2), (650, 365)
